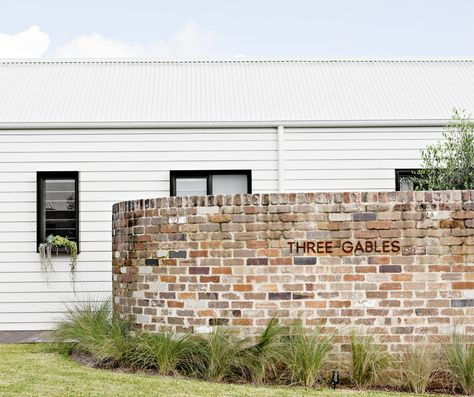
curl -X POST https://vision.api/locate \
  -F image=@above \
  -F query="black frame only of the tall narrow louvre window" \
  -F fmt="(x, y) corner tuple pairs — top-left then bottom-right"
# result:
(36, 171), (80, 253)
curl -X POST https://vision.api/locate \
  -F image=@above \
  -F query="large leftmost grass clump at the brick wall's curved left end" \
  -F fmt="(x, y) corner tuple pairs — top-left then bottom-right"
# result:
(55, 299), (131, 366)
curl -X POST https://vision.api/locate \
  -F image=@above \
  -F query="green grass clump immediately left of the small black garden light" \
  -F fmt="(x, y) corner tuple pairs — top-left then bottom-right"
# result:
(284, 323), (333, 387)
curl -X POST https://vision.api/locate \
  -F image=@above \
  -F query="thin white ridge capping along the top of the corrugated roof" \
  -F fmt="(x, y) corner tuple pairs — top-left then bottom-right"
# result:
(0, 57), (474, 64)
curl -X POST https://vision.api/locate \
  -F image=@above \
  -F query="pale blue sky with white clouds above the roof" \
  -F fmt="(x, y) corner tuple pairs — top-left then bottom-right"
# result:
(0, 0), (474, 59)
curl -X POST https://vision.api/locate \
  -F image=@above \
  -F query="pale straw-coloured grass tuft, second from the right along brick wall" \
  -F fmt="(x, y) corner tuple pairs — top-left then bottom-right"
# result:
(400, 346), (438, 394)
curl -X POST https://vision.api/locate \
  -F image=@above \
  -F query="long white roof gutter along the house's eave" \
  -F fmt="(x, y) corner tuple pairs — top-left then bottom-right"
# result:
(0, 119), (450, 130)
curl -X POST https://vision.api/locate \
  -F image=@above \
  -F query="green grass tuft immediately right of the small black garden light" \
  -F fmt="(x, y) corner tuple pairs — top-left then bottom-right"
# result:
(350, 332), (390, 388)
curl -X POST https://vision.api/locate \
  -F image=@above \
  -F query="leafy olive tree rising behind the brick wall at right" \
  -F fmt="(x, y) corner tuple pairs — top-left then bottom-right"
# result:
(415, 109), (474, 190)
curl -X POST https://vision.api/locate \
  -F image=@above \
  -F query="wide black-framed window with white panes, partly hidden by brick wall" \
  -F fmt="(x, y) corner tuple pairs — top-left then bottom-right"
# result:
(170, 170), (252, 196)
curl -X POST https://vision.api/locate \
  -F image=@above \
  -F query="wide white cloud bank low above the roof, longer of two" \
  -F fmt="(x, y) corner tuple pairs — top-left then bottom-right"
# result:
(54, 22), (218, 58)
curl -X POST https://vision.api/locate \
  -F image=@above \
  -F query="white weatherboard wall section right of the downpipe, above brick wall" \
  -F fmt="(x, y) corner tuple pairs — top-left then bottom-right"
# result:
(285, 127), (442, 192)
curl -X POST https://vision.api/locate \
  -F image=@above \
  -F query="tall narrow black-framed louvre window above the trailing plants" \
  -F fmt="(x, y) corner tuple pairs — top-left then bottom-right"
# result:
(36, 171), (79, 252)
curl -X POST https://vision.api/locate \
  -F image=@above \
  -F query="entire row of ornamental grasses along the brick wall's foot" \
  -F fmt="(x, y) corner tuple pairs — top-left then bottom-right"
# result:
(56, 300), (474, 395)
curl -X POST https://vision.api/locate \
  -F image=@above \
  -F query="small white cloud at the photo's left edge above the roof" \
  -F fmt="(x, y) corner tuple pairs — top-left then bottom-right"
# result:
(0, 26), (50, 58)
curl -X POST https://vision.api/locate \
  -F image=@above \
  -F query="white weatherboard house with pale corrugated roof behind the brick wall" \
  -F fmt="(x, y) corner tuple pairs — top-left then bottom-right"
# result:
(0, 60), (474, 339)
